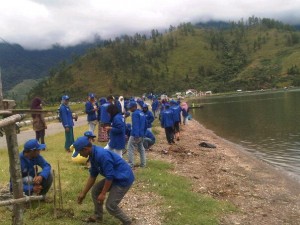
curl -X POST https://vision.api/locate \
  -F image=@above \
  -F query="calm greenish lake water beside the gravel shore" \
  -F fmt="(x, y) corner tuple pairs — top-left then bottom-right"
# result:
(190, 89), (300, 179)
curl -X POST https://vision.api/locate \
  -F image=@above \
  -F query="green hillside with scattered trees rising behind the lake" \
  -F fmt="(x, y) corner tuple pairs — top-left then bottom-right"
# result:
(29, 17), (300, 102)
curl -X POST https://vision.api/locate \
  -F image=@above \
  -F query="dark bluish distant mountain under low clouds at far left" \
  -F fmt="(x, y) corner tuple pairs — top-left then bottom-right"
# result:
(0, 42), (100, 91)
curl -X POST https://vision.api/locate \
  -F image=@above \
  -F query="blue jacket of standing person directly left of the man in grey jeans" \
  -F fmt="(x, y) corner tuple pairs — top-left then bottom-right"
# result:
(108, 113), (126, 150)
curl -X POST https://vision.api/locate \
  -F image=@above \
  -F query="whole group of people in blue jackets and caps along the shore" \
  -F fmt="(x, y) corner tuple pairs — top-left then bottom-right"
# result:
(13, 94), (186, 224)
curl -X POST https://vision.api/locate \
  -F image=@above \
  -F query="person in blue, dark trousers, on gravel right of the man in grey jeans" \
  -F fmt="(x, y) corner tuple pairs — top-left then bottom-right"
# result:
(161, 103), (175, 145)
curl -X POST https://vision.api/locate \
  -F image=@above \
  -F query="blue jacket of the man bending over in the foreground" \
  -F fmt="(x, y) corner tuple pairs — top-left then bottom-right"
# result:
(90, 145), (134, 187)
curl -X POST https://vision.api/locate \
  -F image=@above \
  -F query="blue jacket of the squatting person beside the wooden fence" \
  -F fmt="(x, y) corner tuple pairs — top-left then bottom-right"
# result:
(19, 152), (51, 195)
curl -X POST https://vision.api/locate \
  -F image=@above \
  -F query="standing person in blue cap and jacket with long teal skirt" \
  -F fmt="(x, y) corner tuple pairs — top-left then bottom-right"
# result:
(59, 95), (74, 152)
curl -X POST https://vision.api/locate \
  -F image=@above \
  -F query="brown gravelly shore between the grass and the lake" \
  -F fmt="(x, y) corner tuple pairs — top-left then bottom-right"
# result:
(144, 120), (300, 225)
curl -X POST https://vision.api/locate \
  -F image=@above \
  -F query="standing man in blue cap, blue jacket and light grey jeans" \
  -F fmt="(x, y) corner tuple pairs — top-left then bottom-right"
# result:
(128, 101), (147, 167)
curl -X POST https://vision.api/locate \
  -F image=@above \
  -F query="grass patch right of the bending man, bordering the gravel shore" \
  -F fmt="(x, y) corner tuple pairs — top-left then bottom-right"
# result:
(136, 160), (235, 225)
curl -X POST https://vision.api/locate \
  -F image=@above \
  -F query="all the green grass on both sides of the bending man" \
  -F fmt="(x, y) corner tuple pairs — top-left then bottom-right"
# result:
(0, 122), (233, 225)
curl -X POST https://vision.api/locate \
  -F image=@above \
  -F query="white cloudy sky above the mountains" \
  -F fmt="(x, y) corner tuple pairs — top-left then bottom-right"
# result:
(0, 0), (300, 49)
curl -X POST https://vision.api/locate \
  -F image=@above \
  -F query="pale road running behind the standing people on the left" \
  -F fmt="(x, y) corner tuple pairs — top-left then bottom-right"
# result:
(0, 116), (87, 151)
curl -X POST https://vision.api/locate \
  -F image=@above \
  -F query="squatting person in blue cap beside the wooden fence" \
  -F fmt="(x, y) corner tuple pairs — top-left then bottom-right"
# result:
(11, 139), (53, 196)
